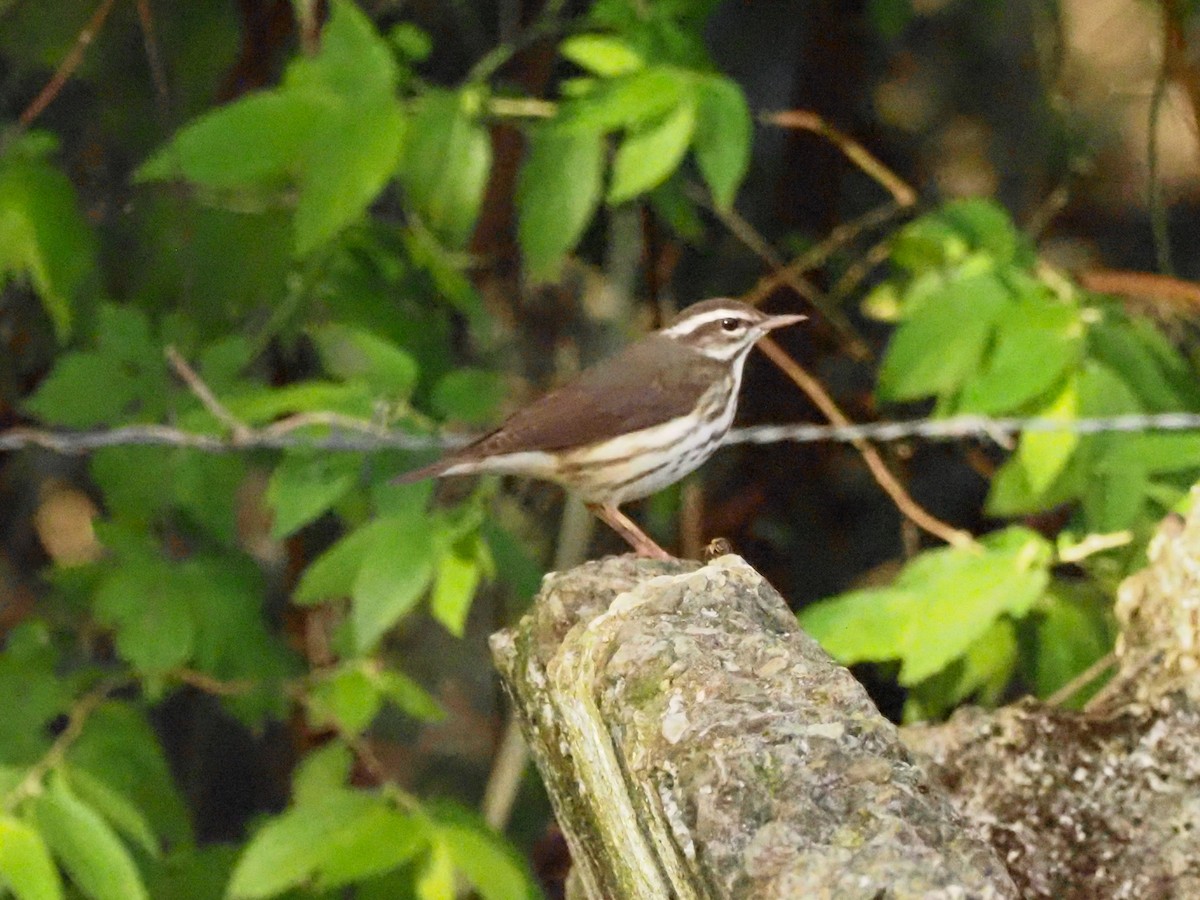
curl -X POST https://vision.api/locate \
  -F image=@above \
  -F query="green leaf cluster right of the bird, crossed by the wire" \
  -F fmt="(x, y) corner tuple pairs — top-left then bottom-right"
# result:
(802, 200), (1200, 718)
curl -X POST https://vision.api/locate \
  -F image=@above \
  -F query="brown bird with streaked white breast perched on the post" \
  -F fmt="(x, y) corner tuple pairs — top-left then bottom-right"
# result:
(394, 298), (808, 559)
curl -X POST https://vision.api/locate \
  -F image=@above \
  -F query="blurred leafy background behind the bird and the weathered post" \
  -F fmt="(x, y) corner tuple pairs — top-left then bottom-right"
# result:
(0, 0), (1200, 900)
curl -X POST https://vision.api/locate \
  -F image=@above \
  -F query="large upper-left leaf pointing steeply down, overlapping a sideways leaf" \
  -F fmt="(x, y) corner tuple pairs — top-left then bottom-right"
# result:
(295, 100), (405, 254)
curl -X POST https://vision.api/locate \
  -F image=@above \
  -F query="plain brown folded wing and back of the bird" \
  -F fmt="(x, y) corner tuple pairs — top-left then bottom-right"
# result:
(454, 335), (722, 460)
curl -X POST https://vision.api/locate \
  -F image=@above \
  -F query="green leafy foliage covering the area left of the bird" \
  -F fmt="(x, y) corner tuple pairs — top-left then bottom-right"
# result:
(0, 0), (750, 900)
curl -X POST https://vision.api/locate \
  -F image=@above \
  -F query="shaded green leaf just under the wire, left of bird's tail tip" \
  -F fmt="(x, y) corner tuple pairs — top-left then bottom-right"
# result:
(266, 450), (362, 539)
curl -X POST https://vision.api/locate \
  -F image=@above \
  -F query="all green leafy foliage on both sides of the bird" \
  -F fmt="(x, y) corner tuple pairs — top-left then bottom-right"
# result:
(7, 0), (1200, 900)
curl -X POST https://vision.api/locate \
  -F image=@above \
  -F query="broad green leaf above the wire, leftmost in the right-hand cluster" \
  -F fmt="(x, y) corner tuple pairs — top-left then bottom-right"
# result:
(878, 272), (1010, 401)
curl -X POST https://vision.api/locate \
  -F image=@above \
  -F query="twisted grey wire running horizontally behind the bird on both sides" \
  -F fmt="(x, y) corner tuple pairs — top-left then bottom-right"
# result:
(0, 413), (1200, 454)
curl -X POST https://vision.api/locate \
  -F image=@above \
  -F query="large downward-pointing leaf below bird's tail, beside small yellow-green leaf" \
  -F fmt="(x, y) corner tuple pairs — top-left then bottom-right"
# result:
(350, 517), (434, 652)
